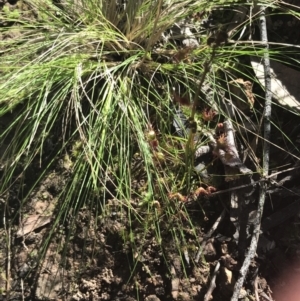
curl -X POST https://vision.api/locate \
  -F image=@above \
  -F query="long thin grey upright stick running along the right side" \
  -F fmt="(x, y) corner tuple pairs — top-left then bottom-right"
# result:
(231, 6), (272, 301)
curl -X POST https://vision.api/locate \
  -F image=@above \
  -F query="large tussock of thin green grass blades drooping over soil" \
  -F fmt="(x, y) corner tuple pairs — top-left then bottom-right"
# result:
(0, 0), (300, 296)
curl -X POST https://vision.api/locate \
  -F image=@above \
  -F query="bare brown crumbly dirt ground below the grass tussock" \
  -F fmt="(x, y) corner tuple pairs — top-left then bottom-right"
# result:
(0, 0), (300, 301)
